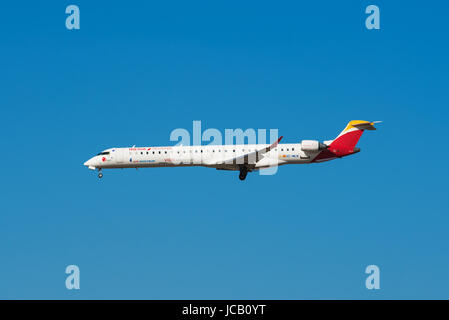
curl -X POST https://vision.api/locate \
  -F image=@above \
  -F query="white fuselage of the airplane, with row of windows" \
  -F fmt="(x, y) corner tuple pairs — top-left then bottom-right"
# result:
(84, 143), (320, 170)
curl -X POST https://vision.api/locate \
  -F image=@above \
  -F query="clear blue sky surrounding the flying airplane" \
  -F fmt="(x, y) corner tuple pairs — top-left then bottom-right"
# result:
(0, 0), (449, 299)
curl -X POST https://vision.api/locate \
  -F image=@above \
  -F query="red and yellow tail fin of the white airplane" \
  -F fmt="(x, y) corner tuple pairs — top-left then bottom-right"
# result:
(328, 120), (380, 156)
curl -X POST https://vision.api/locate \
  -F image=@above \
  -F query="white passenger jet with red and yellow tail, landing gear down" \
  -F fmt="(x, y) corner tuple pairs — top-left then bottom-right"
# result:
(84, 120), (381, 180)
